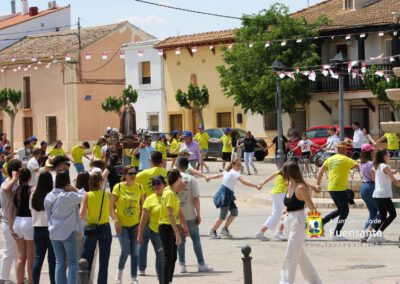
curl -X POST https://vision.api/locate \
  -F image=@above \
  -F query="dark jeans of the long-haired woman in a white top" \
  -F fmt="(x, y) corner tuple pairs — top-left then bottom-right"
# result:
(32, 227), (56, 284)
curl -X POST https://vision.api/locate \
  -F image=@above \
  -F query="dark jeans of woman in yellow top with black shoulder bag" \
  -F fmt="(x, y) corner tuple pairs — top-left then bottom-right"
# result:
(82, 223), (112, 284)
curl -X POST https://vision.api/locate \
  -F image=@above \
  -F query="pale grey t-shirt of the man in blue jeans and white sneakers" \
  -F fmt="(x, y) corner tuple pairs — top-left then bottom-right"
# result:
(178, 173), (200, 220)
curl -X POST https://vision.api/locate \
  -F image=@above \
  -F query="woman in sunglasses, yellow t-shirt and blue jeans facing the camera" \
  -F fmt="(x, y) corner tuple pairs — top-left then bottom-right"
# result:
(110, 166), (145, 283)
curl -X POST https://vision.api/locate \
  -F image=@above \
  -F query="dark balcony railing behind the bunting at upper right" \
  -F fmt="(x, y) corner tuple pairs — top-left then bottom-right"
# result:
(310, 64), (393, 93)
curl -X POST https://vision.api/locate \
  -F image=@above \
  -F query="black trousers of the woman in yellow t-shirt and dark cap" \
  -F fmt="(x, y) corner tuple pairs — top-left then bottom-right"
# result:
(158, 224), (178, 284)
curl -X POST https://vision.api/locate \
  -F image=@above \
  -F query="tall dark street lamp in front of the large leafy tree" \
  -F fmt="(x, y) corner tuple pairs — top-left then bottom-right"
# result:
(271, 60), (286, 168)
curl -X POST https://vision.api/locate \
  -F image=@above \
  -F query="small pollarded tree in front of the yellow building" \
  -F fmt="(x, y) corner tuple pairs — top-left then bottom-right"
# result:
(175, 84), (209, 127)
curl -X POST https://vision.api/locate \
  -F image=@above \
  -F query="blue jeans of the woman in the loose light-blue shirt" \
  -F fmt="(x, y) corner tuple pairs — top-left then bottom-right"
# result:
(51, 232), (78, 284)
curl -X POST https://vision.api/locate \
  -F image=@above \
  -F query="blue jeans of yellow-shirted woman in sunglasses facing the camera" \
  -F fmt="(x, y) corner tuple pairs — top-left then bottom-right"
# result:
(118, 225), (138, 277)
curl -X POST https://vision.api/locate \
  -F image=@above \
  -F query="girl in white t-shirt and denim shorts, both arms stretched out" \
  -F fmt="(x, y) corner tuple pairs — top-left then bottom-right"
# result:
(208, 159), (261, 239)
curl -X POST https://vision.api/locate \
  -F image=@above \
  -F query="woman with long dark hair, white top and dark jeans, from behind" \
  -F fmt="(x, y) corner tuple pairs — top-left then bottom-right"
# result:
(29, 172), (56, 284)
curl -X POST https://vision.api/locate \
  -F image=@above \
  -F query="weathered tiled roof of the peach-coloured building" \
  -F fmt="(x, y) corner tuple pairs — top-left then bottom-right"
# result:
(0, 22), (129, 65)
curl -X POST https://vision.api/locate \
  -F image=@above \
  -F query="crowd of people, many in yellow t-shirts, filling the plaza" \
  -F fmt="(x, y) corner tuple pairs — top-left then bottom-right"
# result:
(0, 124), (400, 284)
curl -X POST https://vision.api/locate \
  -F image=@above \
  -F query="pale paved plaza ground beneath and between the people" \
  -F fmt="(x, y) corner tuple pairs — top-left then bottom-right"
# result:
(0, 162), (400, 284)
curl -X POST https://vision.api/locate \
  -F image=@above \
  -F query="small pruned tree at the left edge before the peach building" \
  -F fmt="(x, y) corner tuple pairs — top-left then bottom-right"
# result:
(0, 88), (22, 148)
